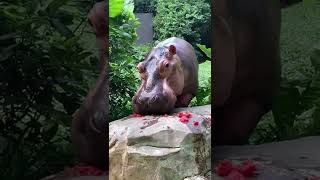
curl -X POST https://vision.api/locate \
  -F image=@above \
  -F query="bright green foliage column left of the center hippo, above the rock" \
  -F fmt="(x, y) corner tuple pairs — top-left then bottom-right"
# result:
(109, 1), (140, 121)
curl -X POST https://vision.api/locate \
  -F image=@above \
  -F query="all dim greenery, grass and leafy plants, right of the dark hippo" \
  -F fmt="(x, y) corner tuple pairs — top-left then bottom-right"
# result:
(251, 4), (320, 144)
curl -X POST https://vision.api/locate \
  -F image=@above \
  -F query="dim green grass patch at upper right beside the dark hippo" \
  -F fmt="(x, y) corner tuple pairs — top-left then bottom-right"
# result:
(280, 0), (320, 79)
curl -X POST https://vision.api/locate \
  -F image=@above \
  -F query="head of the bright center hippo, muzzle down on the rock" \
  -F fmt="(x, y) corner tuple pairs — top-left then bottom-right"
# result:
(132, 45), (184, 114)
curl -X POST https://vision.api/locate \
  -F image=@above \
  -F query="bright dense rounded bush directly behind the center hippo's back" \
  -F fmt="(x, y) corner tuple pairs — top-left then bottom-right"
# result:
(153, 0), (211, 60)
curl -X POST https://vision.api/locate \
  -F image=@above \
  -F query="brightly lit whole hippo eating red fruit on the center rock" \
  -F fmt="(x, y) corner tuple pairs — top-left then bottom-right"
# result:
(132, 37), (198, 114)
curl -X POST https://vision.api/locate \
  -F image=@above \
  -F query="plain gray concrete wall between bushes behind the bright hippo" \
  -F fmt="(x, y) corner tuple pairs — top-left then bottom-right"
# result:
(135, 13), (153, 44)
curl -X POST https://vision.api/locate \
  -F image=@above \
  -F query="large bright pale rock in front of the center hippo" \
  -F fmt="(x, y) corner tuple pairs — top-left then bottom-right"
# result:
(109, 106), (211, 180)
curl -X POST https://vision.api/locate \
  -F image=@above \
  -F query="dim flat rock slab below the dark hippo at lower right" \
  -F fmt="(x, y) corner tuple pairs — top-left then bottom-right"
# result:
(213, 136), (320, 180)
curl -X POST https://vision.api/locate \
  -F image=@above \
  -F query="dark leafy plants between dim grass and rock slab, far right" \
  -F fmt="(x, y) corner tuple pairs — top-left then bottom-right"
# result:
(251, 44), (320, 144)
